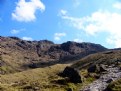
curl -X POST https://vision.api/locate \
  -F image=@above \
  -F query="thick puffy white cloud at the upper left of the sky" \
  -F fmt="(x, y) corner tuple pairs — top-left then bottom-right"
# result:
(12, 0), (45, 22)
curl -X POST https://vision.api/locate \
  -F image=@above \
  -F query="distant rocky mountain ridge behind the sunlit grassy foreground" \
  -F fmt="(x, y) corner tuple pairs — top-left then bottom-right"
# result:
(0, 36), (107, 74)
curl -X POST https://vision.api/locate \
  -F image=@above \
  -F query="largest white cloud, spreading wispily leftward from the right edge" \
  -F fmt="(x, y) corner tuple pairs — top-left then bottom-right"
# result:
(61, 11), (121, 47)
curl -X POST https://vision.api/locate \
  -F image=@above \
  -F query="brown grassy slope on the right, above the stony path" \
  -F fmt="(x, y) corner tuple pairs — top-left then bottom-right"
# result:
(72, 50), (121, 69)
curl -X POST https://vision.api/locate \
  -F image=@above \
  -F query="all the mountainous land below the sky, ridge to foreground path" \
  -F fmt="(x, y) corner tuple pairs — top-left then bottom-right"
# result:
(0, 36), (121, 91)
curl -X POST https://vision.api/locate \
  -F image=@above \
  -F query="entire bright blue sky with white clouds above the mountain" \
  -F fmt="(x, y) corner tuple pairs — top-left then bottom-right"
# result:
(0, 0), (121, 48)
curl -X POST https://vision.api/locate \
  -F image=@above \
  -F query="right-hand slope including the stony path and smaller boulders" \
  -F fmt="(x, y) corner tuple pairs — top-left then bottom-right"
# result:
(67, 49), (121, 91)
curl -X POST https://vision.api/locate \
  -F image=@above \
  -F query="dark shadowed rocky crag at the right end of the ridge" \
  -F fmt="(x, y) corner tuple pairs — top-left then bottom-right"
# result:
(61, 41), (105, 54)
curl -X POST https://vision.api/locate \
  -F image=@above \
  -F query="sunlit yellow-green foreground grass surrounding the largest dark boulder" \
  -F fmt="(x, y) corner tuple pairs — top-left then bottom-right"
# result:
(0, 64), (95, 91)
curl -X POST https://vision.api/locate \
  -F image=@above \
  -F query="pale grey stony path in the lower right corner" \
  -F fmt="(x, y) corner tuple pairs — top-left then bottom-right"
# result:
(80, 66), (121, 91)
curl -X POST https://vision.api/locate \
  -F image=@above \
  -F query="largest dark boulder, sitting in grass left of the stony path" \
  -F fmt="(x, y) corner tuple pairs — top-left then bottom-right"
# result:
(62, 67), (82, 83)
